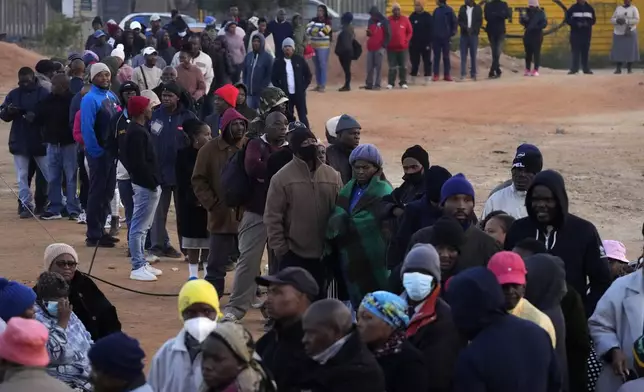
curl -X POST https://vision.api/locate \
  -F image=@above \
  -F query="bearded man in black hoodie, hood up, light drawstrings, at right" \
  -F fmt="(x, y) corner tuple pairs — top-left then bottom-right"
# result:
(505, 170), (611, 316)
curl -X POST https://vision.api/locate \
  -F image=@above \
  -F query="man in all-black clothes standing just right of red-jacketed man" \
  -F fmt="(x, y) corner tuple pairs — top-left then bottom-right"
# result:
(409, 1), (433, 84)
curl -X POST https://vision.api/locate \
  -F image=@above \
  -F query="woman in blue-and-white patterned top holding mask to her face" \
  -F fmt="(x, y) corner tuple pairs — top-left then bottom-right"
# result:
(36, 271), (94, 391)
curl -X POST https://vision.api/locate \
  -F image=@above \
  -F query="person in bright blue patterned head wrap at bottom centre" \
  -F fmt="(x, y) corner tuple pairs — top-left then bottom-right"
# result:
(358, 291), (429, 392)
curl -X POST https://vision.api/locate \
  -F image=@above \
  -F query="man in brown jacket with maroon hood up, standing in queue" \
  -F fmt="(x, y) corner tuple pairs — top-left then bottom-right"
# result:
(192, 108), (248, 296)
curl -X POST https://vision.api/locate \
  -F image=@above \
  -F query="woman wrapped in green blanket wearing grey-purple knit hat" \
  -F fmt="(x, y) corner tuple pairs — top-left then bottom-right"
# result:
(325, 144), (393, 309)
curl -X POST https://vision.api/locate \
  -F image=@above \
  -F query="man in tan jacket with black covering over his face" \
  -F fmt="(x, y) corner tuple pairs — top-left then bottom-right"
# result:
(264, 128), (342, 292)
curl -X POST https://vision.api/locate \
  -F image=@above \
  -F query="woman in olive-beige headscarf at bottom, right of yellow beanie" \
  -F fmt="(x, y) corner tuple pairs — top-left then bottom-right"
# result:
(201, 322), (276, 392)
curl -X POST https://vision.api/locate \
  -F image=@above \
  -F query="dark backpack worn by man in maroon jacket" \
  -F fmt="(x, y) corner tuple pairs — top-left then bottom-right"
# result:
(221, 139), (266, 208)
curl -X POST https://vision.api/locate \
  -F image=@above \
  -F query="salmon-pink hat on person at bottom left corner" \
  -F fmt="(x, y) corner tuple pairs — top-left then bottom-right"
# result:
(0, 317), (49, 367)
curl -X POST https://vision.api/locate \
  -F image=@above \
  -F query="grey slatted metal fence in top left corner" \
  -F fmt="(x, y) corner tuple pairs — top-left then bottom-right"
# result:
(0, 0), (58, 39)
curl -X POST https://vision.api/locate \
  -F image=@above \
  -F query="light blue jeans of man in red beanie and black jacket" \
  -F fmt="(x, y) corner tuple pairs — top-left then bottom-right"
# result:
(128, 184), (161, 270)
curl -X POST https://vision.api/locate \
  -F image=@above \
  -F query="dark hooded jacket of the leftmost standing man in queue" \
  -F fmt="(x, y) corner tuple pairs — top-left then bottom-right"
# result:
(0, 83), (49, 157)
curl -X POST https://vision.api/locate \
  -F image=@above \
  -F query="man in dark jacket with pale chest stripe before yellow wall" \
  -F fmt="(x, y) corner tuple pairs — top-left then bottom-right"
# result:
(566, 0), (596, 75)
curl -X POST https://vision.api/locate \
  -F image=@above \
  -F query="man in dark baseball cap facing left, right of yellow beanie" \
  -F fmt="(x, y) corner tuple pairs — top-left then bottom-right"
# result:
(255, 267), (320, 390)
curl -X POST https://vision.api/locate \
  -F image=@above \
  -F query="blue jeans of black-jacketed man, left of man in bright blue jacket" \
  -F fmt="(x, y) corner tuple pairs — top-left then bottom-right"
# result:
(47, 143), (81, 214)
